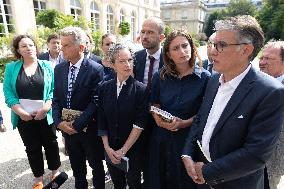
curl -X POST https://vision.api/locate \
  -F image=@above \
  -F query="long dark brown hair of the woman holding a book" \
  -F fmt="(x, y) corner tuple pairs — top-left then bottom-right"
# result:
(160, 30), (202, 79)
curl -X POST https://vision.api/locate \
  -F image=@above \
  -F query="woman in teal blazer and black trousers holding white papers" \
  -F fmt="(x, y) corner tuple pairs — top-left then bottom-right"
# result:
(3, 35), (60, 189)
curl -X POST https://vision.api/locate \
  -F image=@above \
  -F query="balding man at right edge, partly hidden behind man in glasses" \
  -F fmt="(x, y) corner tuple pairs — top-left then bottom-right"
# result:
(259, 41), (284, 189)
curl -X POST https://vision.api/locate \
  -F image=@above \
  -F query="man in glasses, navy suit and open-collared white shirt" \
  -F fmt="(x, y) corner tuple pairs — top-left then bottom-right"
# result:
(182, 15), (284, 189)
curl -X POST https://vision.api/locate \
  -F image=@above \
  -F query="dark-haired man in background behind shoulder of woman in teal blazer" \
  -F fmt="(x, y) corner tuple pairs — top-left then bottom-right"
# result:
(38, 34), (64, 67)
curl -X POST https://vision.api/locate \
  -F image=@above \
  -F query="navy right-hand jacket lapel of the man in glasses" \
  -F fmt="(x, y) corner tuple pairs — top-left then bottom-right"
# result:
(211, 68), (256, 139)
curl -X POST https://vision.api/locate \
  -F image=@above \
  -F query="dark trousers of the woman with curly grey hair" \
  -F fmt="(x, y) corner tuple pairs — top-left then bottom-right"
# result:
(107, 152), (143, 189)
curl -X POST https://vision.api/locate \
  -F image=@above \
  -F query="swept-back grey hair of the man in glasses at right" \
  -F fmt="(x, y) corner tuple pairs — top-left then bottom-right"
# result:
(215, 15), (264, 60)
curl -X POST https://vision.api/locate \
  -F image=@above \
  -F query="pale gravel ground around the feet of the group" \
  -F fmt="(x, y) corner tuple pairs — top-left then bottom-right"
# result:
(0, 83), (112, 189)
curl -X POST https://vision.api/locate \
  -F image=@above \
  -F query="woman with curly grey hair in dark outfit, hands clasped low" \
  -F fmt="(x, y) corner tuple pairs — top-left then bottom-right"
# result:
(98, 44), (148, 189)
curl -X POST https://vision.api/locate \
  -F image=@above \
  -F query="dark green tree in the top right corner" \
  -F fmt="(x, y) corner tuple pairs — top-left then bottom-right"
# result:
(257, 0), (284, 41)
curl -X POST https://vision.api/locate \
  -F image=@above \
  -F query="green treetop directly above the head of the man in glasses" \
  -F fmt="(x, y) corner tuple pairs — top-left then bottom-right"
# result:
(226, 0), (257, 16)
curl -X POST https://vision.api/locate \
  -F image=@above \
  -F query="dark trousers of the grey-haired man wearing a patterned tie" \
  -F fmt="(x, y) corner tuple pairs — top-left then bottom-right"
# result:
(64, 128), (105, 189)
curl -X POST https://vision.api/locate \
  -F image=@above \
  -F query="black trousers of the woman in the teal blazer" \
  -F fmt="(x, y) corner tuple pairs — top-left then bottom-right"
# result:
(17, 119), (61, 177)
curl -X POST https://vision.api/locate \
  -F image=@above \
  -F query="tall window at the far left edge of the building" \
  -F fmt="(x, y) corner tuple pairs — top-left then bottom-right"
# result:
(0, 0), (14, 36)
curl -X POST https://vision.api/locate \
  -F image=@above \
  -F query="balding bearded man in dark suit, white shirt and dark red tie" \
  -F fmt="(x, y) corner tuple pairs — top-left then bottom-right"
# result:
(133, 17), (165, 88)
